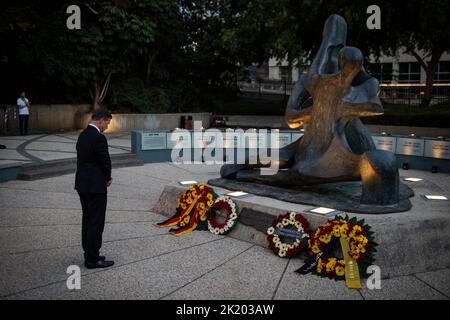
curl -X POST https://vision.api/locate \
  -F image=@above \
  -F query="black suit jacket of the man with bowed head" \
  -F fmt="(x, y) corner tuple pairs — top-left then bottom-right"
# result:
(75, 126), (111, 193)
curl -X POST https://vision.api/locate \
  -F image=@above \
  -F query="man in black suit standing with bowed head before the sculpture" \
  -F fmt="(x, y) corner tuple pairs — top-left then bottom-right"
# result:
(75, 108), (114, 269)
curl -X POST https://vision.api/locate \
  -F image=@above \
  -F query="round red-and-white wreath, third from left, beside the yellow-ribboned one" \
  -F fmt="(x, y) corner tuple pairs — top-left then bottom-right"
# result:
(267, 212), (310, 258)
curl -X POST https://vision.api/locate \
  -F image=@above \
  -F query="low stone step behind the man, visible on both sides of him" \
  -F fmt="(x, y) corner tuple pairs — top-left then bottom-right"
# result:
(17, 153), (144, 181)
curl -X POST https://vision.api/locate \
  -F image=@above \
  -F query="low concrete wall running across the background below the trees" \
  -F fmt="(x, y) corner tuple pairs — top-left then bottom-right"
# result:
(0, 104), (450, 138)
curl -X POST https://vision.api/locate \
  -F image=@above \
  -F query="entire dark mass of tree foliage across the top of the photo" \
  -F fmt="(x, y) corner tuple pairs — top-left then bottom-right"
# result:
(0, 0), (450, 112)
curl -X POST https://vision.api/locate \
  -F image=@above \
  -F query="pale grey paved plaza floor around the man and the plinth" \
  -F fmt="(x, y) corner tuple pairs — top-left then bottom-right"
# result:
(0, 133), (450, 300)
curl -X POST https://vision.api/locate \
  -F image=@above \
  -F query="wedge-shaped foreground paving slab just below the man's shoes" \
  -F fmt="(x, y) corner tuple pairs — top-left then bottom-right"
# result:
(7, 239), (251, 299)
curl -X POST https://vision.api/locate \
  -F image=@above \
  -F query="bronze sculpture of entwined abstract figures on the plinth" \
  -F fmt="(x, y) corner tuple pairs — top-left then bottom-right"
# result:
(221, 15), (399, 205)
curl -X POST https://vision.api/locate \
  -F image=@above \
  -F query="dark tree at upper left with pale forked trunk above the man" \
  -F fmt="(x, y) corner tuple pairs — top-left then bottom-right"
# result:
(0, 0), (173, 106)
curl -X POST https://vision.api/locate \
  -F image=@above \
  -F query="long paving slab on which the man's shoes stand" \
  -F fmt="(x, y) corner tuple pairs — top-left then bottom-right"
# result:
(0, 231), (214, 297)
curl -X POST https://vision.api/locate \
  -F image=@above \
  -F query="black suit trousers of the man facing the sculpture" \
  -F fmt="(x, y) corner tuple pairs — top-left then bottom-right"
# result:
(78, 192), (107, 263)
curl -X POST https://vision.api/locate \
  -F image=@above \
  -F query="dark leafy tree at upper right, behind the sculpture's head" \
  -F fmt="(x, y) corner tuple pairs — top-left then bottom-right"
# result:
(216, 0), (450, 106)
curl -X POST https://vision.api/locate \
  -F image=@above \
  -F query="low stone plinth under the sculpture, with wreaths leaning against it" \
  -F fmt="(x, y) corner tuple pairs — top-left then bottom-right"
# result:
(151, 184), (450, 278)
